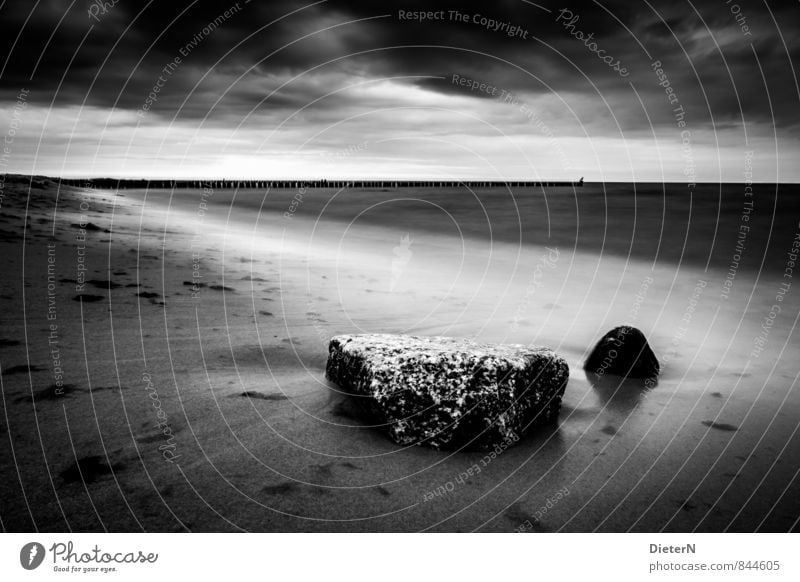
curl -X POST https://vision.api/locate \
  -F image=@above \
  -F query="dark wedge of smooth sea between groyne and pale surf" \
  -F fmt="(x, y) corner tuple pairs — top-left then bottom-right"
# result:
(191, 183), (800, 272)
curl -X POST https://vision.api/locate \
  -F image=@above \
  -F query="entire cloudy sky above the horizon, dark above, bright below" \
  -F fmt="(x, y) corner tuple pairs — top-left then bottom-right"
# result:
(0, 0), (800, 182)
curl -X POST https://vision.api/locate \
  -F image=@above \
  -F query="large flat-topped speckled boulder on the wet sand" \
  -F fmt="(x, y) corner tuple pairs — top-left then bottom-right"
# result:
(326, 334), (569, 448)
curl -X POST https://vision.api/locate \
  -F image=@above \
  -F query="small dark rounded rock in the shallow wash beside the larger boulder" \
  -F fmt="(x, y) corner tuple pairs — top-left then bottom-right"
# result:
(583, 325), (660, 378)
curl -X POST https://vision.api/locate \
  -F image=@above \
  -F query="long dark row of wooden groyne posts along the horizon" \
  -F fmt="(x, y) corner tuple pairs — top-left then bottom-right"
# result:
(57, 178), (583, 190)
